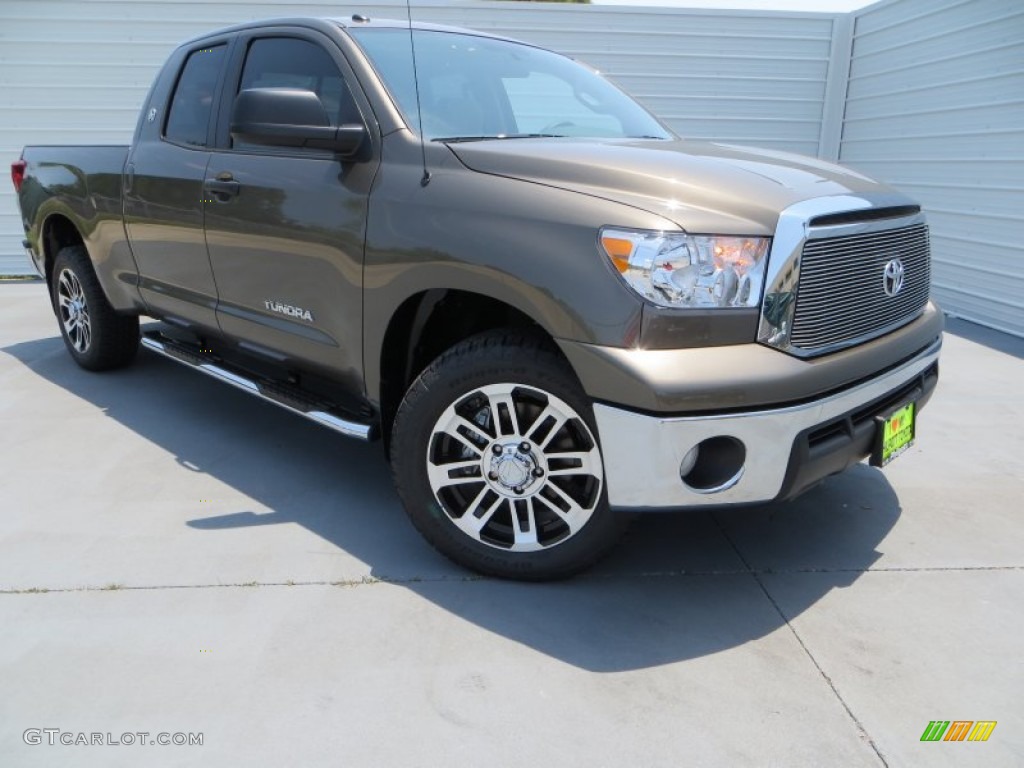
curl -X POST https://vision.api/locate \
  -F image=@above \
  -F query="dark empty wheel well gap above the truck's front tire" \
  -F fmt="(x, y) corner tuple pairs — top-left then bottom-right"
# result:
(380, 290), (560, 446)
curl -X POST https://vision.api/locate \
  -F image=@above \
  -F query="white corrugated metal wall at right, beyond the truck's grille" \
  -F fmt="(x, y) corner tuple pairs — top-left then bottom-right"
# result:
(840, 0), (1024, 335)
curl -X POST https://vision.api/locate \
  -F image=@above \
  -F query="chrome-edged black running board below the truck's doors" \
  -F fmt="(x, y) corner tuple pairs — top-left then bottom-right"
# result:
(141, 332), (377, 440)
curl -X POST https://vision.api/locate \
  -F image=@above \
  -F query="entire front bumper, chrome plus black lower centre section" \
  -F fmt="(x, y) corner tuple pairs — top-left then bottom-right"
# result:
(594, 339), (942, 509)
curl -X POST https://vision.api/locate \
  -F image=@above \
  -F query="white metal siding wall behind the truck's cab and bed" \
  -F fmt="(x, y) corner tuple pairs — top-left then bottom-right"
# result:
(0, 0), (846, 273)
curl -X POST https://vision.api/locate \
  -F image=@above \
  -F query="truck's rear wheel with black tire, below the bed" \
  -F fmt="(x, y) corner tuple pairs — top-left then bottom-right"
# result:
(51, 246), (138, 371)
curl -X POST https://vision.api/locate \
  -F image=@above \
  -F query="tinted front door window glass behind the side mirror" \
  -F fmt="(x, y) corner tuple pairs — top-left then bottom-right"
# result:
(233, 37), (361, 146)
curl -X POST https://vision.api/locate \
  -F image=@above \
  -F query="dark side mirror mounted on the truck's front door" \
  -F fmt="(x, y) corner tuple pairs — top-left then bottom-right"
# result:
(230, 88), (367, 158)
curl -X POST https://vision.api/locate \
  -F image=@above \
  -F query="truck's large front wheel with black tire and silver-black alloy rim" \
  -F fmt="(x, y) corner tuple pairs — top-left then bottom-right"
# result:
(390, 331), (626, 581)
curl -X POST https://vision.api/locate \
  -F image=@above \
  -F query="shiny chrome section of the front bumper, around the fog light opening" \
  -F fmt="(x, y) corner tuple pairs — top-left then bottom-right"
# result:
(594, 339), (942, 509)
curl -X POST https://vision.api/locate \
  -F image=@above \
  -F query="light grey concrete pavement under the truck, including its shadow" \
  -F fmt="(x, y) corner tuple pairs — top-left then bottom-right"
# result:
(0, 283), (1024, 768)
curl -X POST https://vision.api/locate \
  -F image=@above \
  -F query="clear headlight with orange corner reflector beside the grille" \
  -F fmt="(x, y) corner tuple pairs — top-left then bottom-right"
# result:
(600, 227), (769, 309)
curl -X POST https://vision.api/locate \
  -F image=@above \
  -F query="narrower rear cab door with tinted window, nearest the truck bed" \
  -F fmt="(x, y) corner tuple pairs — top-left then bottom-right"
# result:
(124, 38), (230, 330)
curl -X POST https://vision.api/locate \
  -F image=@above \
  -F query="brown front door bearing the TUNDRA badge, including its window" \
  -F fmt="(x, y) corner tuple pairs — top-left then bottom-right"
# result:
(206, 27), (379, 393)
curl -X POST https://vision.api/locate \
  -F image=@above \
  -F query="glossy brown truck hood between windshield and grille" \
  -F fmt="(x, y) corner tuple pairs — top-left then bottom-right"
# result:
(449, 138), (892, 234)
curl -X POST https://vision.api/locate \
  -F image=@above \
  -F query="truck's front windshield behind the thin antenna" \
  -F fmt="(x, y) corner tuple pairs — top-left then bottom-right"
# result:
(347, 28), (672, 141)
